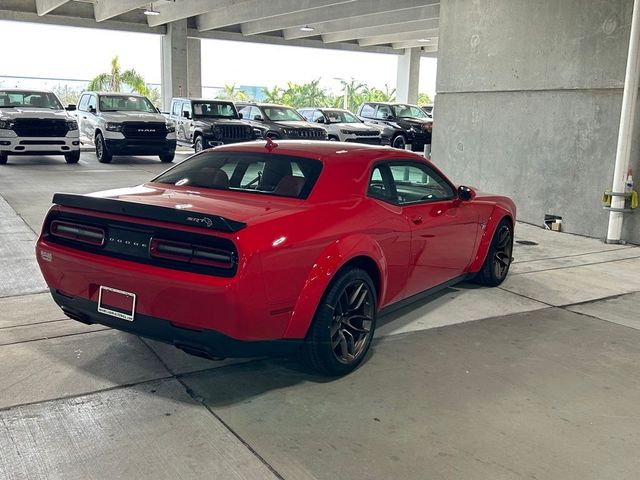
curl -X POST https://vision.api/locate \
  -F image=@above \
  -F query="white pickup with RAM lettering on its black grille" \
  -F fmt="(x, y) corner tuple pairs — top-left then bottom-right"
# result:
(78, 92), (176, 163)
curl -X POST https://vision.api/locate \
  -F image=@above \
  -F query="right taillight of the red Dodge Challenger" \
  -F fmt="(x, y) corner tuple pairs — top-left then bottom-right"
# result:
(149, 238), (235, 268)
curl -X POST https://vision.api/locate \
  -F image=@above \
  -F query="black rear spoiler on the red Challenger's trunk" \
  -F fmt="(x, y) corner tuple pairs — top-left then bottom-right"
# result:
(53, 193), (247, 233)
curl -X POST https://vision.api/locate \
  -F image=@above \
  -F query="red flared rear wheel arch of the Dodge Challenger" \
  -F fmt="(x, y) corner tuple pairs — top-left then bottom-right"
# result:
(284, 234), (387, 339)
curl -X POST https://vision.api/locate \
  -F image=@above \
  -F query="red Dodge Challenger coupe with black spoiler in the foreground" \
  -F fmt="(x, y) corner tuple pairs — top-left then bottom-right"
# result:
(36, 140), (515, 375)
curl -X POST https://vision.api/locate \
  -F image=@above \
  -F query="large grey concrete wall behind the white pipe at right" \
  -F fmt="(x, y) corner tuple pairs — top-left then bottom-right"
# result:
(432, 0), (640, 243)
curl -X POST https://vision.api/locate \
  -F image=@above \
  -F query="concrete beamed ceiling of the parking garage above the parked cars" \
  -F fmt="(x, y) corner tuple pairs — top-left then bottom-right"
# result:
(0, 0), (440, 56)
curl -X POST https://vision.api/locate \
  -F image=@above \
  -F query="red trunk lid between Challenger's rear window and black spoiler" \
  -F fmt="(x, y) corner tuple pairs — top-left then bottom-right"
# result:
(89, 183), (303, 225)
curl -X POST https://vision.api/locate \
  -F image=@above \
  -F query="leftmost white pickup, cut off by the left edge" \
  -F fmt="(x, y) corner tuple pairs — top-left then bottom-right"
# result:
(0, 89), (80, 164)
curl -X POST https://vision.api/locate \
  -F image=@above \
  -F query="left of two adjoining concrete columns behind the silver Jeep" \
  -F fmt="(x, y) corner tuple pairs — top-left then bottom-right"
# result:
(162, 20), (189, 111)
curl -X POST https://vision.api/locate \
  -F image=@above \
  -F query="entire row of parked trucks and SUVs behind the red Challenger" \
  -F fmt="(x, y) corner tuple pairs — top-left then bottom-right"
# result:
(0, 90), (433, 164)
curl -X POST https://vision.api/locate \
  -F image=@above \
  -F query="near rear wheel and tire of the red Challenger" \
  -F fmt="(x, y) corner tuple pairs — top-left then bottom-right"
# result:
(301, 268), (378, 376)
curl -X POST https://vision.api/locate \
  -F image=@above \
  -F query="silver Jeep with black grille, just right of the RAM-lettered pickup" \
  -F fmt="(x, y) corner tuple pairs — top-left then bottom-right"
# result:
(167, 97), (262, 152)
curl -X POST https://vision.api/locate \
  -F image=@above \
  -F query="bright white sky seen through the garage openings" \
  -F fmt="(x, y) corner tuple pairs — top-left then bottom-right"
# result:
(0, 21), (436, 98)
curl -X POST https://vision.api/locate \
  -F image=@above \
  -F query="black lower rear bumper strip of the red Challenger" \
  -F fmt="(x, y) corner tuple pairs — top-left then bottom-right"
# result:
(51, 288), (301, 358)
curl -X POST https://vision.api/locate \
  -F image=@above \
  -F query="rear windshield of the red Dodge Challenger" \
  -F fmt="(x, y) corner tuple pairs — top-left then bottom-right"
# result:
(153, 152), (322, 198)
